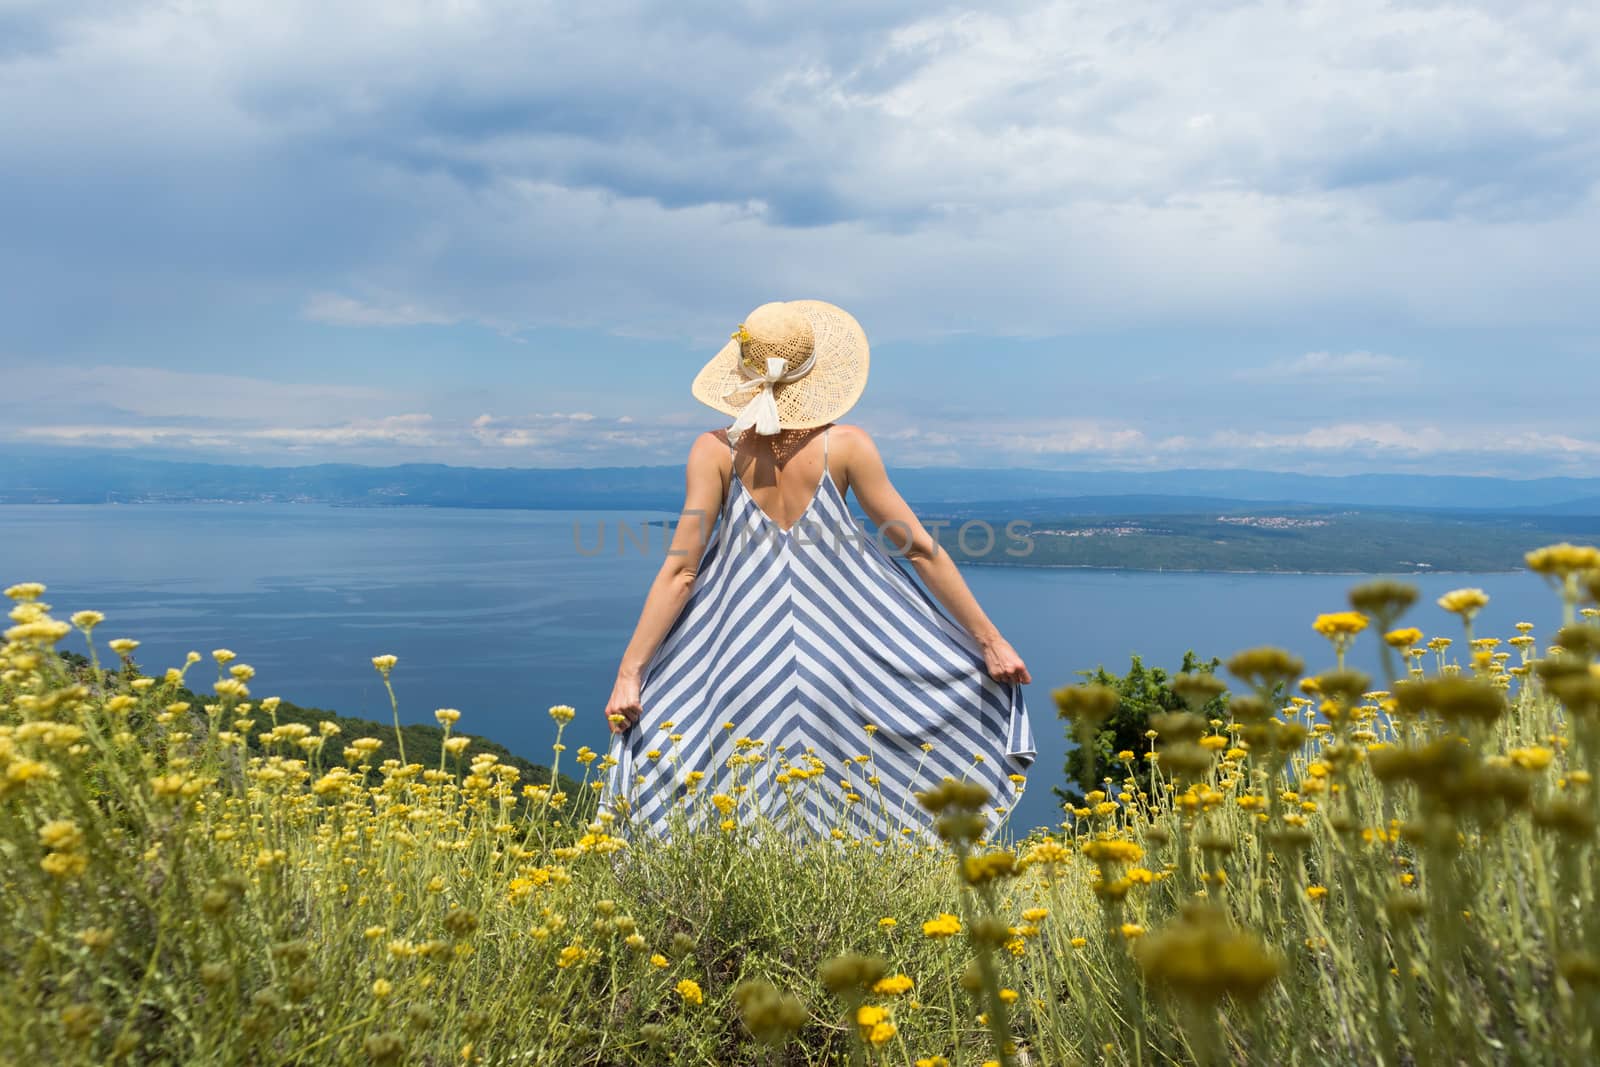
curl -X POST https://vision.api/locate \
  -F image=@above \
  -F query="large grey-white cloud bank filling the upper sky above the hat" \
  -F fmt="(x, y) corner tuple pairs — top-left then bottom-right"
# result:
(0, 0), (1600, 348)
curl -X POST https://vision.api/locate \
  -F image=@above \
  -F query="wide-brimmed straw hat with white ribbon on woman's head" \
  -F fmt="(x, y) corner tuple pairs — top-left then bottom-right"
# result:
(693, 301), (867, 437)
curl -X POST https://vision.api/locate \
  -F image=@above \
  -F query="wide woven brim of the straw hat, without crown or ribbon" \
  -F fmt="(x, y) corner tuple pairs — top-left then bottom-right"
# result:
(690, 301), (870, 430)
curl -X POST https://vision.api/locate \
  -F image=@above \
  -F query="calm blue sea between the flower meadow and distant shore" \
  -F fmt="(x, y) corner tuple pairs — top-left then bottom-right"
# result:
(0, 504), (1560, 835)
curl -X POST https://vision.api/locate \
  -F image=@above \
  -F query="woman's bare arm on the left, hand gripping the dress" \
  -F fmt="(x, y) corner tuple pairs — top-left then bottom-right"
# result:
(605, 432), (731, 734)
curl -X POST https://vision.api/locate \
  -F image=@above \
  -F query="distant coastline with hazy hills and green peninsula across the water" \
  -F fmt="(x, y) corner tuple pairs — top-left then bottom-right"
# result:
(0, 450), (1600, 574)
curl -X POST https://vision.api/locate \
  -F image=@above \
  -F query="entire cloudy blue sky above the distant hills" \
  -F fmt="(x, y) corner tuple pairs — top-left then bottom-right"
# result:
(0, 0), (1600, 477)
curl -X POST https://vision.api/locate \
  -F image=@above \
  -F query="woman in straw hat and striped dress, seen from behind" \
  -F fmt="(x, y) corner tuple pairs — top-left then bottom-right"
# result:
(605, 301), (1035, 840)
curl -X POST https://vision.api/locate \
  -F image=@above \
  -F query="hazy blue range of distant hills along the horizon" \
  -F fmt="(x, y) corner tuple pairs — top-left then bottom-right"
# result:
(9, 450), (1600, 515)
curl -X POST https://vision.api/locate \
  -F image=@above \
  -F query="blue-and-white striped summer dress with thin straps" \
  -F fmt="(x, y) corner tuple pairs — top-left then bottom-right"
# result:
(603, 430), (1035, 841)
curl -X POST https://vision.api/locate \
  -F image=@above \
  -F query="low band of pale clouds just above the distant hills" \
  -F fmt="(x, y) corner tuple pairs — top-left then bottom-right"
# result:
(12, 368), (1600, 477)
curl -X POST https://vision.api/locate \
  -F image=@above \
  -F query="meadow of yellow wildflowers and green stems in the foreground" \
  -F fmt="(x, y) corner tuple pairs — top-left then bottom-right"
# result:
(0, 544), (1600, 1067)
